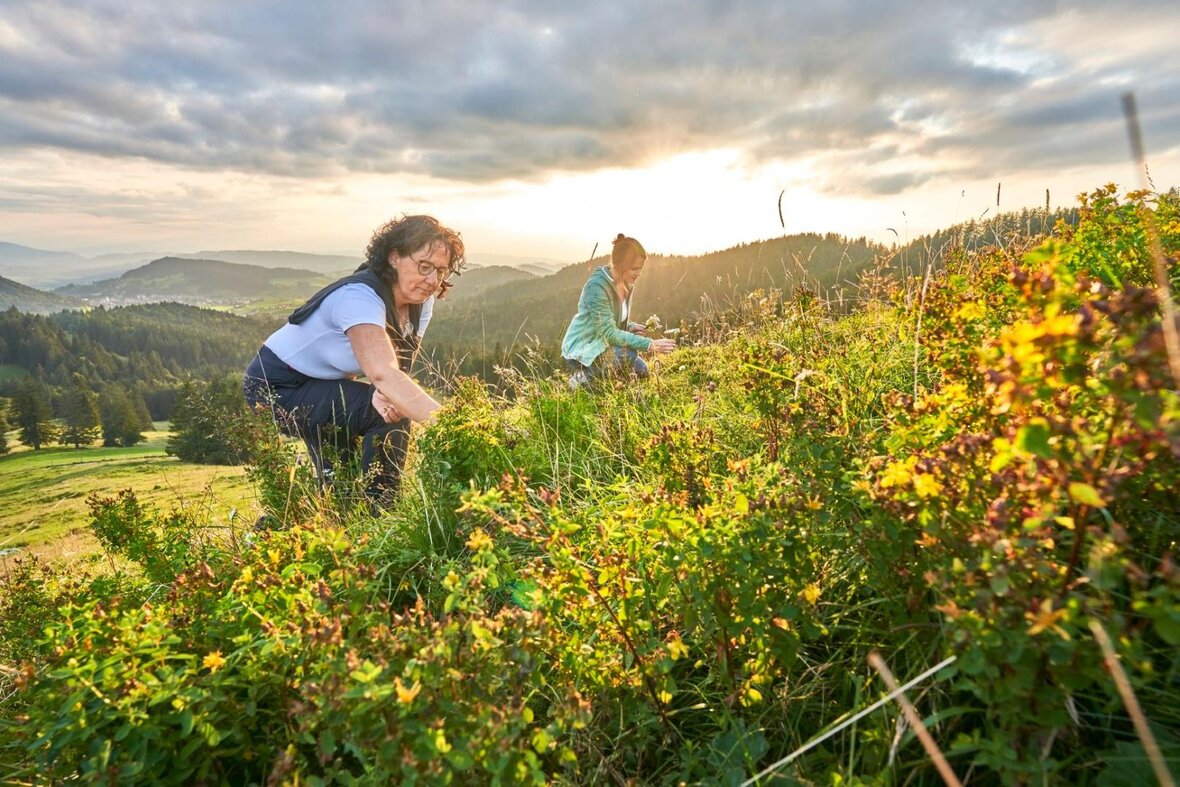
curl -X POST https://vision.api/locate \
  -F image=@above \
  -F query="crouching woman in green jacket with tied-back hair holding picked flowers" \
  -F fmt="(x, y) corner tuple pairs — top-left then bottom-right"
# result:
(562, 232), (676, 388)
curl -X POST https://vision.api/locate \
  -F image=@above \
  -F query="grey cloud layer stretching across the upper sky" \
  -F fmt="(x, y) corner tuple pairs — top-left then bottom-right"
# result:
(0, 0), (1180, 194)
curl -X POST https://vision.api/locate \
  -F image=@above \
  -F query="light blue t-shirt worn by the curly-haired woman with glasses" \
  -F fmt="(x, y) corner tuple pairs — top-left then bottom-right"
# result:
(263, 283), (434, 380)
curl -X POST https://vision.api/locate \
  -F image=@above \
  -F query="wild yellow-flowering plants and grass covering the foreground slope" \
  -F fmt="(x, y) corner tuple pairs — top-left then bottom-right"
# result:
(0, 188), (1180, 785)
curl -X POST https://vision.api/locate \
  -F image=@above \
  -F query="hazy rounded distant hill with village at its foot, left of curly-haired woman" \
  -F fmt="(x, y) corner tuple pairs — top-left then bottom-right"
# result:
(57, 257), (330, 306)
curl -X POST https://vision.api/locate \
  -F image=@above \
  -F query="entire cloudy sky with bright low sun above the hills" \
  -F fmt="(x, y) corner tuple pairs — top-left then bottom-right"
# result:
(0, 0), (1180, 261)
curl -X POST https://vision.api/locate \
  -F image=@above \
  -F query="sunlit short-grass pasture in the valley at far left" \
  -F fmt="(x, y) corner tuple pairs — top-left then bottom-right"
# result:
(0, 421), (257, 557)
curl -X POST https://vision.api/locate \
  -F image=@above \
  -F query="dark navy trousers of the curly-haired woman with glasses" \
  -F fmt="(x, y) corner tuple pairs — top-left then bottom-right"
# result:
(242, 346), (409, 500)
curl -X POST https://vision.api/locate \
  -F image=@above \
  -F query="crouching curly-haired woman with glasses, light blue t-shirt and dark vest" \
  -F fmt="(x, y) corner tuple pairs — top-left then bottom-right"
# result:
(243, 216), (465, 504)
